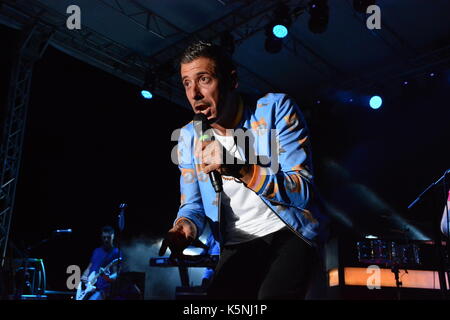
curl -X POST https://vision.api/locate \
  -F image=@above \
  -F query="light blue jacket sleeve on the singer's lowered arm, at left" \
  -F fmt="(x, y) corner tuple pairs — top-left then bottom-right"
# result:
(174, 125), (206, 237)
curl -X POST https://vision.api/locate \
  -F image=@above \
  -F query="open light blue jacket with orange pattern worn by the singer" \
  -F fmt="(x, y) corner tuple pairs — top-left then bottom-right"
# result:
(175, 93), (321, 245)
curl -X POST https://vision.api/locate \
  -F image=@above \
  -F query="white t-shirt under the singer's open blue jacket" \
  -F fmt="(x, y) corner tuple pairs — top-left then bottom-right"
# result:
(214, 132), (286, 245)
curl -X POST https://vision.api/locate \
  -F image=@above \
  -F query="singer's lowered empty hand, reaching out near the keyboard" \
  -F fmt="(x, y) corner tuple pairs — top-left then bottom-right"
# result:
(159, 218), (196, 258)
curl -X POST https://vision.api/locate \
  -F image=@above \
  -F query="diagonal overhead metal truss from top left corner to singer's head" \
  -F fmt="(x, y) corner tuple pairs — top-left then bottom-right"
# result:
(0, 0), (190, 106)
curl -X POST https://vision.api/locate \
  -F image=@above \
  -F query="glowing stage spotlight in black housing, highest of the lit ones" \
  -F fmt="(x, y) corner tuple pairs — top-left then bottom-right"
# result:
(264, 3), (292, 53)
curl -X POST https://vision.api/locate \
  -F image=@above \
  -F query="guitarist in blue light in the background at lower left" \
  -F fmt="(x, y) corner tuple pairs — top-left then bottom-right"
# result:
(81, 226), (122, 300)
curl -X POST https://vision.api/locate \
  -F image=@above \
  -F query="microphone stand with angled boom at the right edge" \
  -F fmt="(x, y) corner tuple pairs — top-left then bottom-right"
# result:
(408, 169), (450, 299)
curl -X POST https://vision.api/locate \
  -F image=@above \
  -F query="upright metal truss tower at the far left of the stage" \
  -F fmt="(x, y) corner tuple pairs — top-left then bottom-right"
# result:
(0, 25), (52, 267)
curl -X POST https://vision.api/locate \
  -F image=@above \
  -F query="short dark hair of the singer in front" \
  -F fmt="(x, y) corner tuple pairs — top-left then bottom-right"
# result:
(179, 40), (236, 81)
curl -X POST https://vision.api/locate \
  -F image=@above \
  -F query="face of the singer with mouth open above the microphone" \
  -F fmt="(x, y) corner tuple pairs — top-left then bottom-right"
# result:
(181, 57), (232, 122)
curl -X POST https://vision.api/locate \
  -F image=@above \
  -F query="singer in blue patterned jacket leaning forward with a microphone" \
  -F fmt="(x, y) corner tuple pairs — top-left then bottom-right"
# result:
(160, 41), (325, 299)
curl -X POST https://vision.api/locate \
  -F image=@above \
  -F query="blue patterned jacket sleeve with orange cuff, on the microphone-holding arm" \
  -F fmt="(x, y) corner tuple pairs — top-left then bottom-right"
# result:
(247, 95), (312, 210)
